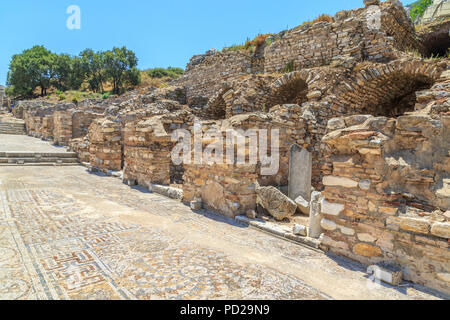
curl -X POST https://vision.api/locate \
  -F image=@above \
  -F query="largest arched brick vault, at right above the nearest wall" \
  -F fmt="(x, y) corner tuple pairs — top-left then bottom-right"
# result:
(330, 60), (442, 117)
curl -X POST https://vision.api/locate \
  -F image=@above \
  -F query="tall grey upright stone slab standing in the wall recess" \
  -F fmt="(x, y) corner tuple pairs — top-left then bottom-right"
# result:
(289, 144), (312, 202)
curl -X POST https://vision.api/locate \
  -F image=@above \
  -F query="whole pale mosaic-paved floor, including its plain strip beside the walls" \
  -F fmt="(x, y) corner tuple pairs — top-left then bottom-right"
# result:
(0, 167), (444, 300)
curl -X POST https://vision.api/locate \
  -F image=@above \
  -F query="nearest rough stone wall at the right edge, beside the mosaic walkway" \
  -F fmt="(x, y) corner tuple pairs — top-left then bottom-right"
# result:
(321, 114), (450, 292)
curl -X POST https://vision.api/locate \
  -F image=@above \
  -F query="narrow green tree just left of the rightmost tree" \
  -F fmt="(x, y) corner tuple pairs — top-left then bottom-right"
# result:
(80, 49), (105, 92)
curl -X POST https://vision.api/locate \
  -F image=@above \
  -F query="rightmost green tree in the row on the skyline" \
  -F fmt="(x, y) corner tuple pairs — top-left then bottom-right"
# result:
(104, 47), (141, 94)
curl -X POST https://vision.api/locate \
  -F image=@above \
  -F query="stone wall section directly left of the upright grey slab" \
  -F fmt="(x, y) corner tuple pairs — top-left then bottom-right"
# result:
(183, 105), (310, 217)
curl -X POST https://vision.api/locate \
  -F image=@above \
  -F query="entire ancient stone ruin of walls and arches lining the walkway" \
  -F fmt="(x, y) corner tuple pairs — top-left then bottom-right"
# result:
(7, 0), (450, 292)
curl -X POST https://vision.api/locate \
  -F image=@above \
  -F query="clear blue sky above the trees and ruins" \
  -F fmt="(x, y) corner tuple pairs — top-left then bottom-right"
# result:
(0, 0), (412, 84)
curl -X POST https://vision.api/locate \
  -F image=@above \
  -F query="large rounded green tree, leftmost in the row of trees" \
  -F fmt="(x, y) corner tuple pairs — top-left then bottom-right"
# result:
(7, 46), (56, 97)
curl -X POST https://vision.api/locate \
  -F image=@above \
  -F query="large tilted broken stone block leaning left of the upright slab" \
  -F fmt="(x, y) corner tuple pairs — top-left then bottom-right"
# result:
(256, 187), (297, 221)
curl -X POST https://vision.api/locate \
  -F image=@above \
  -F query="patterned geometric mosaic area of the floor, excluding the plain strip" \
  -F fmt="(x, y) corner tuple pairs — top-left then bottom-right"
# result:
(0, 189), (326, 299)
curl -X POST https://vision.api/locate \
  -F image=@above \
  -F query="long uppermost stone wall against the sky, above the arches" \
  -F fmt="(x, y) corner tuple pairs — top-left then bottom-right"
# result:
(174, 1), (423, 106)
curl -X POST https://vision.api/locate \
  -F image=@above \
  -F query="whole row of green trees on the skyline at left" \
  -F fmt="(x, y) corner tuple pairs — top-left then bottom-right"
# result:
(7, 46), (141, 97)
